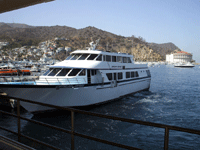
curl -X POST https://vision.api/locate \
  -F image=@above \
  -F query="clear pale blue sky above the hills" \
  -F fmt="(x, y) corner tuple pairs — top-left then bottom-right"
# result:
(0, 0), (200, 63)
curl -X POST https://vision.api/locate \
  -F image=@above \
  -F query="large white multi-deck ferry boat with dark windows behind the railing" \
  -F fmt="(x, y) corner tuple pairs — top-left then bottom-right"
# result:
(0, 42), (151, 112)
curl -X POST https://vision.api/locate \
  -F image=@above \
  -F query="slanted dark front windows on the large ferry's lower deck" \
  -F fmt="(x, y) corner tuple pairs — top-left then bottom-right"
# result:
(43, 68), (86, 76)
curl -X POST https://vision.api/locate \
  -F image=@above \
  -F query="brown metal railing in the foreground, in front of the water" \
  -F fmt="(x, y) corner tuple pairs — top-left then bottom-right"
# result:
(0, 95), (200, 150)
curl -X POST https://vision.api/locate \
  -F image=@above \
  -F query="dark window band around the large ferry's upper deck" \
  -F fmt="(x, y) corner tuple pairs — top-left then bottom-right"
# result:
(66, 54), (132, 63)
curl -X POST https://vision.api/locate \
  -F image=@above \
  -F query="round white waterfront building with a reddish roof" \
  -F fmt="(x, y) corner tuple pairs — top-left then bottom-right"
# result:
(166, 51), (192, 63)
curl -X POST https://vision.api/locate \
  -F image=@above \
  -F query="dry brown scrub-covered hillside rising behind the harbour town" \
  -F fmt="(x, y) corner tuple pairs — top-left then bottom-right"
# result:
(0, 23), (178, 61)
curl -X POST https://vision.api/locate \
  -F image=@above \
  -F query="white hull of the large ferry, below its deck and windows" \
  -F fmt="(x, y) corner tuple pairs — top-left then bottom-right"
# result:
(1, 78), (151, 112)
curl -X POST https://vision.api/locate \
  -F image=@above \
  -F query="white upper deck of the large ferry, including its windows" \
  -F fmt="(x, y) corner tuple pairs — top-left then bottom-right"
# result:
(51, 50), (147, 69)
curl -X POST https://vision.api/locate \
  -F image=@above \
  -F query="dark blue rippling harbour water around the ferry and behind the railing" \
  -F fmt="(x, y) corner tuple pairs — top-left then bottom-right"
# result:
(0, 65), (200, 150)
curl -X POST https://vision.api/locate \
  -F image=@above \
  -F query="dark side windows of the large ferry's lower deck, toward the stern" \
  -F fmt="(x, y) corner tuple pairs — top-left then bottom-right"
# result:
(106, 71), (139, 80)
